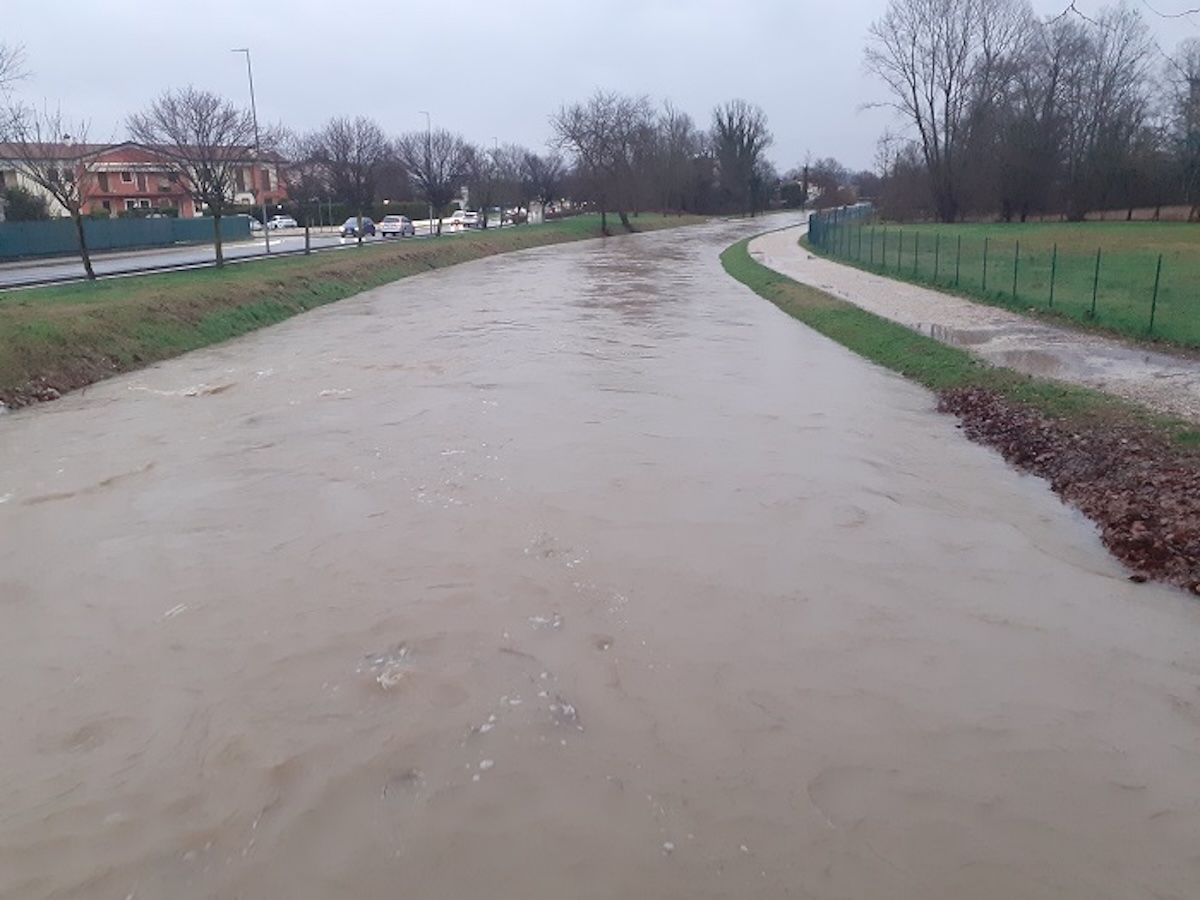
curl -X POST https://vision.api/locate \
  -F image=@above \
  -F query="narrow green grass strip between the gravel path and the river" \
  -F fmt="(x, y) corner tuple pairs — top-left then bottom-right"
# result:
(721, 240), (1200, 448)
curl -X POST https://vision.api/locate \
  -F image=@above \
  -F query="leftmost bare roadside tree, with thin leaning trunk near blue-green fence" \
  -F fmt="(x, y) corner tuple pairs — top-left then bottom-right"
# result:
(8, 107), (96, 278)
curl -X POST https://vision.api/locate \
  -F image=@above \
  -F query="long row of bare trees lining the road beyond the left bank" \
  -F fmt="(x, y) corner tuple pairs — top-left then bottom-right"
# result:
(0, 44), (776, 277)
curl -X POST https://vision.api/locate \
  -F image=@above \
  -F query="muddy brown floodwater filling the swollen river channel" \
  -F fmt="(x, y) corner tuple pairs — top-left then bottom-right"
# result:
(0, 223), (1200, 900)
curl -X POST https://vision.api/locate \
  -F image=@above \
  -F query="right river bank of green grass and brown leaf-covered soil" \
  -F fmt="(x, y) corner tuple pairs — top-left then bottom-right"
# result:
(721, 241), (1200, 594)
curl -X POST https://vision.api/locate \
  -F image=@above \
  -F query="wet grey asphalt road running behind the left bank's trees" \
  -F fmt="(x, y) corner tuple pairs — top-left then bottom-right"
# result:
(0, 229), (449, 289)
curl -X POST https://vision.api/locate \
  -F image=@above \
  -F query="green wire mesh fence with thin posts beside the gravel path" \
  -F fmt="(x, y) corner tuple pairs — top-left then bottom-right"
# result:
(809, 205), (1200, 347)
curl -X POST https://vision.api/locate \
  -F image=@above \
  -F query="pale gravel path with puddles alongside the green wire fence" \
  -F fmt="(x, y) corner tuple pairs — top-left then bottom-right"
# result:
(750, 226), (1200, 421)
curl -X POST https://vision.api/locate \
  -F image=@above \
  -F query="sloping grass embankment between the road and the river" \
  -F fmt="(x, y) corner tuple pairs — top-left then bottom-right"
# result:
(0, 214), (703, 407)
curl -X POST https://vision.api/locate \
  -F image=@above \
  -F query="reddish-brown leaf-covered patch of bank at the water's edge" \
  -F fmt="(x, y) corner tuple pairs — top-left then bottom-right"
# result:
(938, 389), (1200, 594)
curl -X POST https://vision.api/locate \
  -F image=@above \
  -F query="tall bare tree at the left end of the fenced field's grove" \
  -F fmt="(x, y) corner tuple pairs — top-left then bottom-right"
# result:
(865, 0), (1032, 222)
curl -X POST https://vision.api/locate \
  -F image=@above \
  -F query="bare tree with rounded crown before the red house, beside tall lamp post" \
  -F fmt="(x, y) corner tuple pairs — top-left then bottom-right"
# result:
(128, 86), (258, 266)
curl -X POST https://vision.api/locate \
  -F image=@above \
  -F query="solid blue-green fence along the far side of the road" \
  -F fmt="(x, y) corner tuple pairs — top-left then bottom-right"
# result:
(0, 216), (250, 259)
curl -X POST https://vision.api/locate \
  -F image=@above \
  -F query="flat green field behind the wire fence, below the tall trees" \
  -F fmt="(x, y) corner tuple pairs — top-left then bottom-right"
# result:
(814, 222), (1200, 348)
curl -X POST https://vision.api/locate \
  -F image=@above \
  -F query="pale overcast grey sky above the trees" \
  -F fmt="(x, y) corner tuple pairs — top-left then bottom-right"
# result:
(0, 0), (1200, 172)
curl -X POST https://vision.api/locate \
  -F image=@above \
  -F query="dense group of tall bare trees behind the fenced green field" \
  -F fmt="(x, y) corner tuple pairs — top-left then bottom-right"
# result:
(865, 0), (1200, 221)
